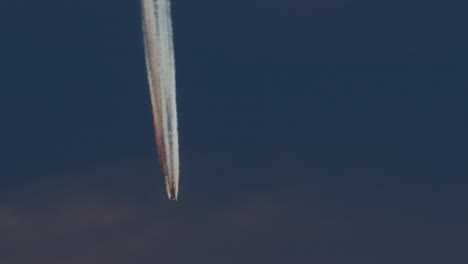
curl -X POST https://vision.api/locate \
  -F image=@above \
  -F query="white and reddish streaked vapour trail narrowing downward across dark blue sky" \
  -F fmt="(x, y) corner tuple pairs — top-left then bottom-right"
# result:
(141, 0), (179, 200)
